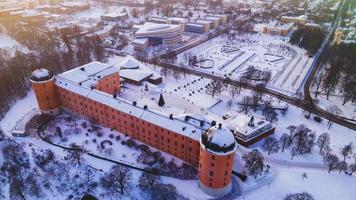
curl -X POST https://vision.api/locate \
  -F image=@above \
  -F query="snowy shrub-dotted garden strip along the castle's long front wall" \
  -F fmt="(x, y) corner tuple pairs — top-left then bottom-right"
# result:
(44, 113), (189, 169)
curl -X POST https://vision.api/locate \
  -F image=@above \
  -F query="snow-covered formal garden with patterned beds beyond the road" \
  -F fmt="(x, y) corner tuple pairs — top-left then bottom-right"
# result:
(176, 33), (312, 94)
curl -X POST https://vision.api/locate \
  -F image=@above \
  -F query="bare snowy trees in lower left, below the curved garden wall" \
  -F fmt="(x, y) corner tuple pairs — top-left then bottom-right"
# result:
(0, 140), (186, 200)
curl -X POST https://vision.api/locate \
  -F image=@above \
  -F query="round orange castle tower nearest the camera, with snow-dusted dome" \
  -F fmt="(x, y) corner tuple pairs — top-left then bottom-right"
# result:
(199, 124), (237, 197)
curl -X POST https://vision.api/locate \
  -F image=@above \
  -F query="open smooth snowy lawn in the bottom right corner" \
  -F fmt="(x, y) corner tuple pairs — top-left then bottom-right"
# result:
(238, 165), (356, 200)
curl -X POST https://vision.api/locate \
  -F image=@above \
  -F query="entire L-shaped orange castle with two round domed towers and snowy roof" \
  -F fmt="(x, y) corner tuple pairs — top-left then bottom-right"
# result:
(31, 62), (272, 197)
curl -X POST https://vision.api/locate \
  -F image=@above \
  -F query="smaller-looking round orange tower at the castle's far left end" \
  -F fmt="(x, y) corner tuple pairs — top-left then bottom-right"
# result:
(31, 68), (59, 114)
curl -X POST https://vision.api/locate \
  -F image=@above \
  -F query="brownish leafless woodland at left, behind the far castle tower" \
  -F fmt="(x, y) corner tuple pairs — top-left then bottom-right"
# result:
(0, 25), (105, 118)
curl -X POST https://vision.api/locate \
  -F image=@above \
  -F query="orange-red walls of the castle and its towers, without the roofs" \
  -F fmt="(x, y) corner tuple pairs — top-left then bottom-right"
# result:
(31, 69), (234, 196)
